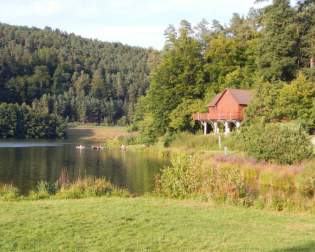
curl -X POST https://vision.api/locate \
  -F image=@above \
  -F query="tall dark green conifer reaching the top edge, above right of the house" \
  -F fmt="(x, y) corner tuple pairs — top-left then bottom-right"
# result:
(257, 0), (298, 81)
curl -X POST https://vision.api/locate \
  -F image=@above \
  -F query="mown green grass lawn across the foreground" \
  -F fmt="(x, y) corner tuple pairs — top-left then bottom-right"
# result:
(0, 197), (315, 251)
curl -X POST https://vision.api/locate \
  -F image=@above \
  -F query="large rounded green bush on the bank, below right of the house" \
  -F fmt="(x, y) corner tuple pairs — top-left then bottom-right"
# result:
(239, 123), (313, 164)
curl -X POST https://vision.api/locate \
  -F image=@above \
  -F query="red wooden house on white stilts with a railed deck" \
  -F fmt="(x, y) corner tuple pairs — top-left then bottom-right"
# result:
(193, 88), (252, 135)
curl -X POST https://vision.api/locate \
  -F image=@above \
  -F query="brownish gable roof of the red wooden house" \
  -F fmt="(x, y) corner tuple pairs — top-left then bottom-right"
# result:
(208, 88), (253, 107)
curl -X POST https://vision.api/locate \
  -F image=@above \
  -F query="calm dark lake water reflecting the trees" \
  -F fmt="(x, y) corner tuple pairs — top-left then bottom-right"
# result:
(0, 141), (167, 194)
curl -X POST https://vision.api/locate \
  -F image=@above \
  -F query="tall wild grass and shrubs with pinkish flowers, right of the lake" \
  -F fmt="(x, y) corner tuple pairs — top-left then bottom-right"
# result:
(156, 155), (315, 210)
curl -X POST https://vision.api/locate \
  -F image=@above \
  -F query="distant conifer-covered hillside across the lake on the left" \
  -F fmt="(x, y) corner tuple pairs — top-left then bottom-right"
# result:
(0, 24), (157, 127)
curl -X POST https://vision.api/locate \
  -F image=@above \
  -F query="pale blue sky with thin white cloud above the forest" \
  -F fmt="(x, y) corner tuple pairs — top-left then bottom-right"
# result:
(0, 0), (282, 49)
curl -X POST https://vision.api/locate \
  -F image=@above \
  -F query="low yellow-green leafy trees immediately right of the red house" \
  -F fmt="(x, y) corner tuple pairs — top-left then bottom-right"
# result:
(246, 74), (315, 132)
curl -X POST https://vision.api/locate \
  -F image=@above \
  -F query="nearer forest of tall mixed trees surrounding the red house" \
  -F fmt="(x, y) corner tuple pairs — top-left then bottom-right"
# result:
(134, 0), (315, 143)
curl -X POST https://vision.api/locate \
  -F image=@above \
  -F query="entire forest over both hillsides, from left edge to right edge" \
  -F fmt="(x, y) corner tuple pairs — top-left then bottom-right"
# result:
(0, 0), (315, 140)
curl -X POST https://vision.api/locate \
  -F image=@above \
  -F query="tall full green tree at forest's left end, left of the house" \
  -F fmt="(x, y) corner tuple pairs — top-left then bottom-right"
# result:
(136, 21), (206, 134)
